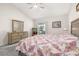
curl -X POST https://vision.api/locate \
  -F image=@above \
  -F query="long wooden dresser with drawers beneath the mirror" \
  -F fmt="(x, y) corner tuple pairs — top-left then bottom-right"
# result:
(8, 32), (28, 44)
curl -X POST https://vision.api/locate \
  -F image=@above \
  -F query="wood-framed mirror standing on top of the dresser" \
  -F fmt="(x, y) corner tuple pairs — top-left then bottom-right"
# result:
(12, 20), (24, 32)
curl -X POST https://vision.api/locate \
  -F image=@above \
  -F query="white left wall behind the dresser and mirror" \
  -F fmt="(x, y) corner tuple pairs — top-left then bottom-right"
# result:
(0, 4), (33, 46)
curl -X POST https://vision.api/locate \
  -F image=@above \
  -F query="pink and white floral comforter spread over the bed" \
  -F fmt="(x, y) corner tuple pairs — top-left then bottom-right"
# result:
(16, 34), (77, 56)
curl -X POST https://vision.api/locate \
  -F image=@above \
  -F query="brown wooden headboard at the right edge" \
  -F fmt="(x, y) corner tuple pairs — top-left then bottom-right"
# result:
(71, 18), (79, 37)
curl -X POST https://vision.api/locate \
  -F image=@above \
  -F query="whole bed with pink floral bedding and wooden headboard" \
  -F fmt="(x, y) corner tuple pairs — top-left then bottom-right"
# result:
(16, 19), (79, 56)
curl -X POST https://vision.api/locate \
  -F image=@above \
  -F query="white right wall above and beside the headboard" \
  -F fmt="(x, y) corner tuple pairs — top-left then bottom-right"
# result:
(69, 3), (79, 33)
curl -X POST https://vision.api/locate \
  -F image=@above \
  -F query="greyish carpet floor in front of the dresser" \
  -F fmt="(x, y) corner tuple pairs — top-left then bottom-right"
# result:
(0, 44), (18, 56)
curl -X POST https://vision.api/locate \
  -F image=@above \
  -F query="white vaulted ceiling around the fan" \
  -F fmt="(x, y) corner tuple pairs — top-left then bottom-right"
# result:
(13, 3), (73, 19)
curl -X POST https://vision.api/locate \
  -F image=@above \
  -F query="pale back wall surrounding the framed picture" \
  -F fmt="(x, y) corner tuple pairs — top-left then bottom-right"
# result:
(36, 15), (69, 34)
